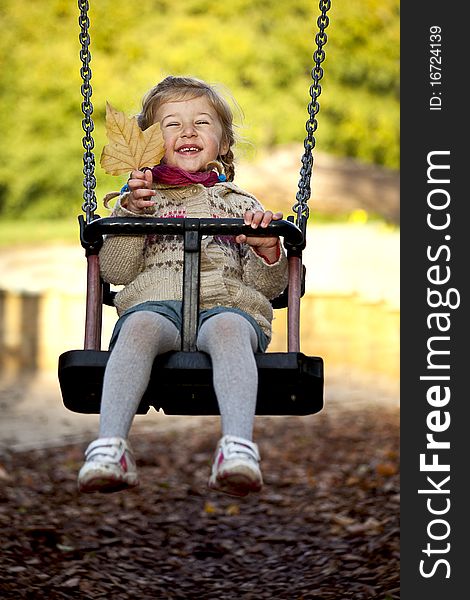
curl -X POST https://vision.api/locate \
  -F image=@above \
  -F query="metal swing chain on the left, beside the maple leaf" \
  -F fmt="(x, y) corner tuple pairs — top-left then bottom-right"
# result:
(78, 0), (97, 223)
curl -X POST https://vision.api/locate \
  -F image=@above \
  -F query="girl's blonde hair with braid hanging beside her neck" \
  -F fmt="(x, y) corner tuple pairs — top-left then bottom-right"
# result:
(137, 75), (236, 181)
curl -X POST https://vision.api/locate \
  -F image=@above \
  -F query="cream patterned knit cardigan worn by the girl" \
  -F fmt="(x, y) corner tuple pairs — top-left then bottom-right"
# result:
(100, 182), (287, 340)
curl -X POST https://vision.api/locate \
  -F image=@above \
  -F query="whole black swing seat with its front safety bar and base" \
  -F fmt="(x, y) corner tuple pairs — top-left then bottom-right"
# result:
(59, 217), (323, 416)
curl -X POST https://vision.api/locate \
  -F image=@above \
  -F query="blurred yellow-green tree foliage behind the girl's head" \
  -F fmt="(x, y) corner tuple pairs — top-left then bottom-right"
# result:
(0, 0), (399, 217)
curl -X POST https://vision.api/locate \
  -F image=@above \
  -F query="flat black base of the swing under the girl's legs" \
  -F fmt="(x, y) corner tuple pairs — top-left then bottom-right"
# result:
(59, 350), (323, 416)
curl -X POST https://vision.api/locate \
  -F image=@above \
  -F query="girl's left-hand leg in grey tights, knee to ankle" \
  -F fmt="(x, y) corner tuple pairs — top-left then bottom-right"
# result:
(99, 311), (180, 438)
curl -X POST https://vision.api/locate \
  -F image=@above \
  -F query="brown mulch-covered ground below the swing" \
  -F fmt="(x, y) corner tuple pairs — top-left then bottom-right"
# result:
(0, 407), (399, 600)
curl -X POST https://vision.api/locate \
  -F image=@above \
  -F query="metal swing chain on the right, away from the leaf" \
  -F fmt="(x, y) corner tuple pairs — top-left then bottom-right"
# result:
(292, 0), (331, 228)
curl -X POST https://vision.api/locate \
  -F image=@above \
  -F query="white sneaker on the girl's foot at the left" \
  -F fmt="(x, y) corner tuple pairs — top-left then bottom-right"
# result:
(78, 437), (139, 493)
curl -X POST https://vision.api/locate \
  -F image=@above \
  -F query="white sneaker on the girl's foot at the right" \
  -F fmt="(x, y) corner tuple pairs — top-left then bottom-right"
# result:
(208, 435), (263, 496)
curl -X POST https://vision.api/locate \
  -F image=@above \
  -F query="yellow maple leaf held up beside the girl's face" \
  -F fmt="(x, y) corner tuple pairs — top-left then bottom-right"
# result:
(100, 102), (165, 175)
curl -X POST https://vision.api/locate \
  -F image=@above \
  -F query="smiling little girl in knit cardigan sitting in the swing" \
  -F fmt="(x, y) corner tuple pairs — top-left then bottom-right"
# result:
(78, 77), (287, 496)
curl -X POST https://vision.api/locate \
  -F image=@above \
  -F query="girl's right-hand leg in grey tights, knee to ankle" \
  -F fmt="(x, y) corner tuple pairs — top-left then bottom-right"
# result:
(197, 312), (258, 440)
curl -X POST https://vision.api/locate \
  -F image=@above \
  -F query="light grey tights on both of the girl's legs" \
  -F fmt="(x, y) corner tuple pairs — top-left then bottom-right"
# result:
(99, 311), (258, 440)
